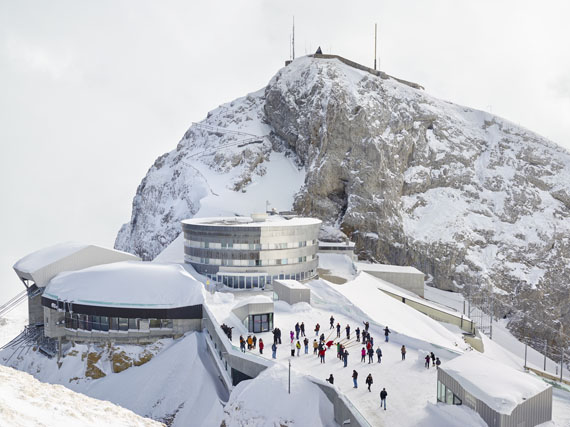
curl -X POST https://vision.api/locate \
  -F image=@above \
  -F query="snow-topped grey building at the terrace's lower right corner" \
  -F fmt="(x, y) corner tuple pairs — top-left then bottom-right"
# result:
(437, 352), (552, 427)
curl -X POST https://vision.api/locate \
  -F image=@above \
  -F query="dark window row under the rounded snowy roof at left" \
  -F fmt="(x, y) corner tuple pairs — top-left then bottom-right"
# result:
(65, 312), (172, 332)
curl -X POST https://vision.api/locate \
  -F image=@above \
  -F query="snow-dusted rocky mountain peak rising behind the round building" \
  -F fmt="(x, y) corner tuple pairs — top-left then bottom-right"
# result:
(116, 57), (570, 352)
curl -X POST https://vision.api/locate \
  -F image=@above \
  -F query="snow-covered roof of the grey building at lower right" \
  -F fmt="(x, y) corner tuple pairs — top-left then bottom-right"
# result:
(440, 351), (550, 415)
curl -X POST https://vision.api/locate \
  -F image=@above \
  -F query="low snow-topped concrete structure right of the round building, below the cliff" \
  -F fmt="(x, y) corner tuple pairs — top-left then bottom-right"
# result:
(354, 262), (425, 298)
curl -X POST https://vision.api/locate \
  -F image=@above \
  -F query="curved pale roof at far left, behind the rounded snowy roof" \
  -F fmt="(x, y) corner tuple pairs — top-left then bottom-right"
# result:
(13, 242), (140, 286)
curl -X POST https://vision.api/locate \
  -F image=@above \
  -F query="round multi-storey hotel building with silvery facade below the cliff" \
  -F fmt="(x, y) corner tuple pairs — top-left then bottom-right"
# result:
(182, 214), (321, 289)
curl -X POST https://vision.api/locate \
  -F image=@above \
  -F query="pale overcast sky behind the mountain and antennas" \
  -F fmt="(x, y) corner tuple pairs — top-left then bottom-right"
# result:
(0, 0), (570, 304)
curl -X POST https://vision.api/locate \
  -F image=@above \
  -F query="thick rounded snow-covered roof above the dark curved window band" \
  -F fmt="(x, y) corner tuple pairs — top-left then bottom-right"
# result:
(44, 261), (204, 308)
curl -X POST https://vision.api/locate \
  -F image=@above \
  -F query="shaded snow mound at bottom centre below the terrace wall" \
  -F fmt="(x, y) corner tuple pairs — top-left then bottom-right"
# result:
(225, 365), (337, 427)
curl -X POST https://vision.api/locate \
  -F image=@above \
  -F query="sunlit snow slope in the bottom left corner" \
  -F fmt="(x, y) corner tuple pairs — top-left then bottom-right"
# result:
(0, 366), (163, 427)
